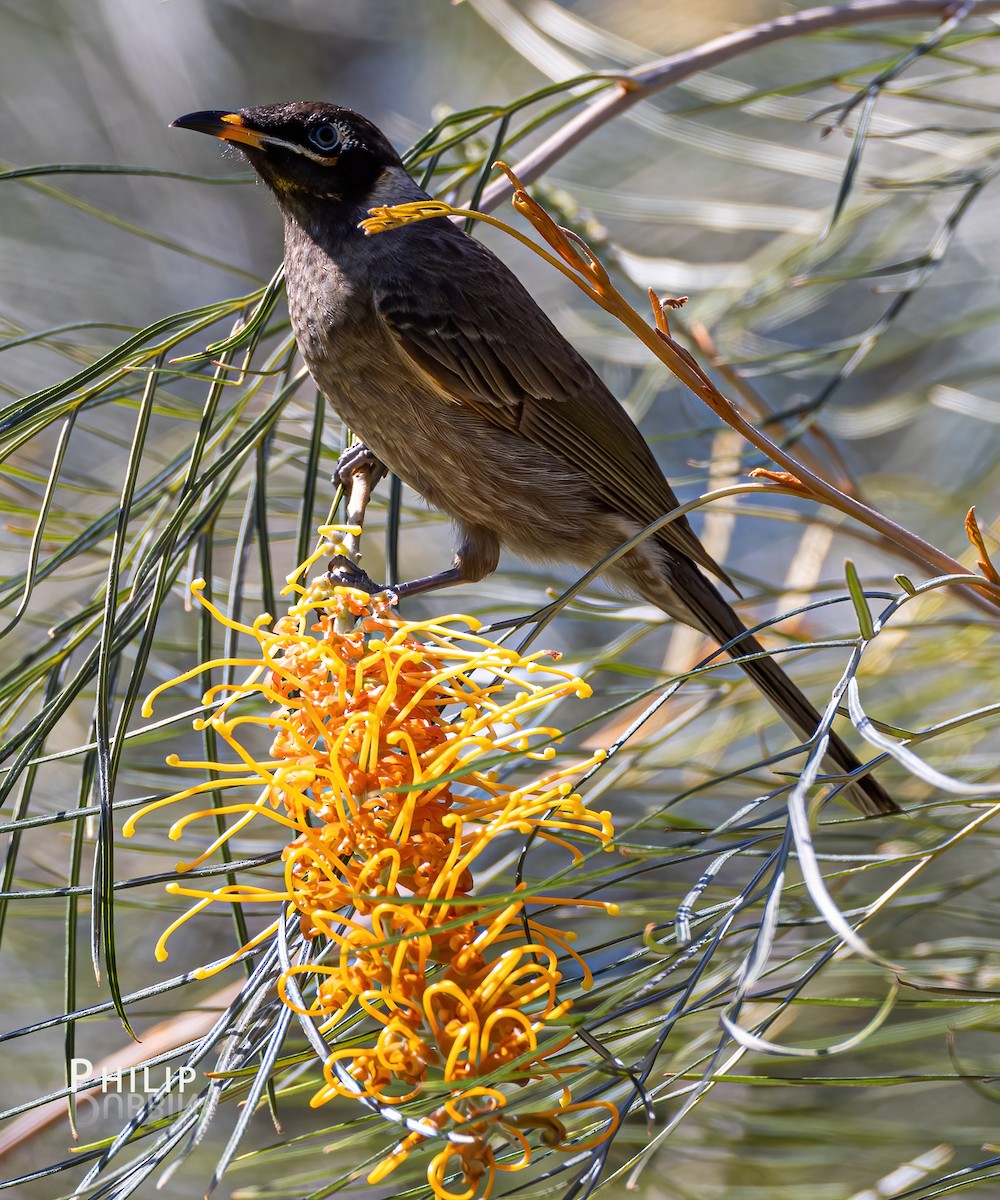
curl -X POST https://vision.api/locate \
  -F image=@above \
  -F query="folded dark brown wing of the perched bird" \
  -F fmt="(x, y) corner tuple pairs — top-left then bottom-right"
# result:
(373, 221), (732, 587)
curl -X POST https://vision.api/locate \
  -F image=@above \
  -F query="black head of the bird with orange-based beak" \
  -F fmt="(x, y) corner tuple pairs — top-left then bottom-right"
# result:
(172, 101), (402, 209)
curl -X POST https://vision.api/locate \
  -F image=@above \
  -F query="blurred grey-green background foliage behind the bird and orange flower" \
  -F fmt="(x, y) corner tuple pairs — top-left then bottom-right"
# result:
(0, 0), (1000, 1200)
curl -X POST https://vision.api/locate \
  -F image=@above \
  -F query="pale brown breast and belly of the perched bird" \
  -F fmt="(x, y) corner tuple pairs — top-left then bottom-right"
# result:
(286, 224), (617, 565)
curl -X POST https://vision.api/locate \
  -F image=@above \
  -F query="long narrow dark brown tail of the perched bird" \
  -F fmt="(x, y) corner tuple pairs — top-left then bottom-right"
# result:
(642, 556), (900, 816)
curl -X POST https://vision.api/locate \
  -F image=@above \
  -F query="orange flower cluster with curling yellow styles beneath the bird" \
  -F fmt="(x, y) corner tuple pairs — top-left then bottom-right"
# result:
(125, 561), (617, 1200)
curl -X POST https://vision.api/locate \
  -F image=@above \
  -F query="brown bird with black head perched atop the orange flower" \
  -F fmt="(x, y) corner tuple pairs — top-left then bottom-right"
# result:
(172, 101), (899, 815)
